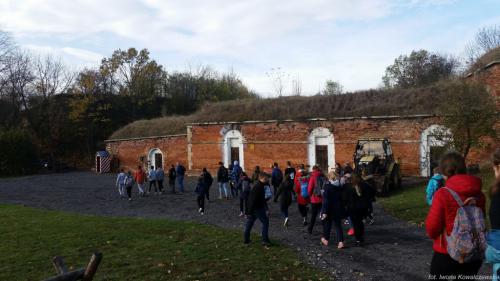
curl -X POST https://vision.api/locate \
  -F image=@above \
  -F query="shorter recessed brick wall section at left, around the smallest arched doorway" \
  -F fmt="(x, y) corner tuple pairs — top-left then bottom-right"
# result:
(106, 136), (187, 170)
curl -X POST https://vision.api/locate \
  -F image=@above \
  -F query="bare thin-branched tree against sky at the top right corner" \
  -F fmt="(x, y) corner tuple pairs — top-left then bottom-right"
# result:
(465, 25), (500, 67)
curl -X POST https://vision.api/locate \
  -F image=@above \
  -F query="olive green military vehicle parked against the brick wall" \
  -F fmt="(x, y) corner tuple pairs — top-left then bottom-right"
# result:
(354, 138), (401, 195)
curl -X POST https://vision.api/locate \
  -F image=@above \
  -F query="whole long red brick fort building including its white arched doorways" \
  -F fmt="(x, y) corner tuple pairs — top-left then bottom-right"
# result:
(106, 61), (500, 176)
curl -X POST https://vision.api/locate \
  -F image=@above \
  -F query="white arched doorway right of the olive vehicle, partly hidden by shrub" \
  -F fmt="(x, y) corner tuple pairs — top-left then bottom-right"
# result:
(420, 125), (453, 177)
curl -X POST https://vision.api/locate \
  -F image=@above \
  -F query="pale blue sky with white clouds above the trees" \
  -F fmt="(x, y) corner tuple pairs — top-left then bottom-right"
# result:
(0, 0), (500, 96)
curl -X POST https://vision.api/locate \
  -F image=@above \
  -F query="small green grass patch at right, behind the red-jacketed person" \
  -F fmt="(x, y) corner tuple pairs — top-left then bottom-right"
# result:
(378, 170), (494, 226)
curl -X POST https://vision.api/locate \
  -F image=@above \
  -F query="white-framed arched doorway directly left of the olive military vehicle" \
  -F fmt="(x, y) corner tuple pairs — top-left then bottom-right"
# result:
(308, 127), (335, 173)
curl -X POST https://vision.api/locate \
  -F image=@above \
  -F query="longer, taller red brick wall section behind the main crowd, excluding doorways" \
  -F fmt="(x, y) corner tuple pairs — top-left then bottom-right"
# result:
(190, 118), (446, 175)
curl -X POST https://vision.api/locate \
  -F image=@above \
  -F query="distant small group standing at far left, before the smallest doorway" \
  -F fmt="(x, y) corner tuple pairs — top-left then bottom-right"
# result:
(116, 163), (186, 201)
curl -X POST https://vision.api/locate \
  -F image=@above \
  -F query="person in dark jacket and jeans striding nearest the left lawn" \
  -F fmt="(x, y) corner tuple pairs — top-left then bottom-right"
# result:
(243, 173), (271, 248)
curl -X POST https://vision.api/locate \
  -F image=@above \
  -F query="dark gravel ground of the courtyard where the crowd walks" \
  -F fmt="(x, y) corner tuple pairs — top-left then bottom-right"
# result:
(0, 172), (488, 281)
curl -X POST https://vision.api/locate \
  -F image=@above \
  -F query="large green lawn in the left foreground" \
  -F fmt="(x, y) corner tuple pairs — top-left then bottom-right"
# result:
(0, 205), (327, 280)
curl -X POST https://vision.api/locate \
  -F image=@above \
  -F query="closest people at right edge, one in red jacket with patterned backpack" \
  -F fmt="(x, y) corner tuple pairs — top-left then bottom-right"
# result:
(425, 149), (500, 281)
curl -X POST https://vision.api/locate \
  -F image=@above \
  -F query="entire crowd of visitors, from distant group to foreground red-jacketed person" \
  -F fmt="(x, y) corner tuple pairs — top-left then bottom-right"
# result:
(116, 149), (500, 281)
